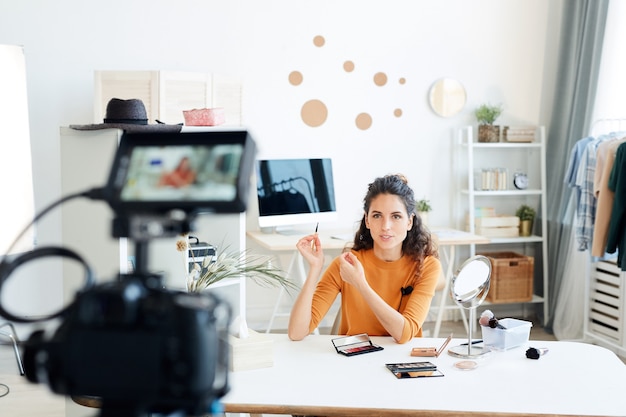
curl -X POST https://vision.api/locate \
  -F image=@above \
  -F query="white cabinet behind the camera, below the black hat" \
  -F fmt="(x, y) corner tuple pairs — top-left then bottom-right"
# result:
(60, 127), (246, 319)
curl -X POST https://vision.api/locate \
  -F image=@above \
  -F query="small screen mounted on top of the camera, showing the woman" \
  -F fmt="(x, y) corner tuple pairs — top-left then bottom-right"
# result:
(107, 130), (254, 213)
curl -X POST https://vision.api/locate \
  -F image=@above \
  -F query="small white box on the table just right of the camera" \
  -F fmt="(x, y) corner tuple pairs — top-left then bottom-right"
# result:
(229, 330), (274, 372)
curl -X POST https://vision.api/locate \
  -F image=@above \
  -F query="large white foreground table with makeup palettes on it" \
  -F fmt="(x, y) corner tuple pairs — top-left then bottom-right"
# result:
(222, 334), (626, 417)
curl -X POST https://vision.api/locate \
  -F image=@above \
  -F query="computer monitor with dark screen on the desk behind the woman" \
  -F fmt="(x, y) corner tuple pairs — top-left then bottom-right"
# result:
(256, 158), (338, 232)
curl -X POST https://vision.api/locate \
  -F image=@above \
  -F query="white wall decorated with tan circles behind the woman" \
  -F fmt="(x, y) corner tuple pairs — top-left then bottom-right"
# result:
(0, 0), (561, 328)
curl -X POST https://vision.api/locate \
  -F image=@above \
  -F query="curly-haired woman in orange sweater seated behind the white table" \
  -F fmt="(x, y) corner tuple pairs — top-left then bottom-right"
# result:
(288, 175), (442, 343)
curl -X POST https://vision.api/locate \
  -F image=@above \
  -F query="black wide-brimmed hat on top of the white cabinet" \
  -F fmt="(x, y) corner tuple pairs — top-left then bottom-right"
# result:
(70, 98), (182, 132)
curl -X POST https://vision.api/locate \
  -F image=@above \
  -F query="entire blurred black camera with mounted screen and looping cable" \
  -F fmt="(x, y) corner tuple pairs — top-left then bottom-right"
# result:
(0, 130), (255, 417)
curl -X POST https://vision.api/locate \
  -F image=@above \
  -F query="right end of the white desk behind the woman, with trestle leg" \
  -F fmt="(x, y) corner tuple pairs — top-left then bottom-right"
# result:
(432, 228), (490, 337)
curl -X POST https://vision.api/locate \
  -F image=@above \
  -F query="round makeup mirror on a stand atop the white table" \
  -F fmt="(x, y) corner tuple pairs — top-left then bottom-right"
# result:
(448, 255), (491, 358)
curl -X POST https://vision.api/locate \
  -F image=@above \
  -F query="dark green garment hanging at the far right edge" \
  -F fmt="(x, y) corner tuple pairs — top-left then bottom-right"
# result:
(607, 143), (626, 271)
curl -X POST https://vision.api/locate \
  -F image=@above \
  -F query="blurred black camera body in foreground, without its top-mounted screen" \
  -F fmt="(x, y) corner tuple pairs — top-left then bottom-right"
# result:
(24, 275), (231, 415)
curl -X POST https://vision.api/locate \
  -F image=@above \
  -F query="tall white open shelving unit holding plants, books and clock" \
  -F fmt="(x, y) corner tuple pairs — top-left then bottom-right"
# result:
(456, 126), (548, 320)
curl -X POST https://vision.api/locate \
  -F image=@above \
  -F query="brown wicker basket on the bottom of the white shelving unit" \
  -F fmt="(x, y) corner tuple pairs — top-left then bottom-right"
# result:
(482, 252), (535, 303)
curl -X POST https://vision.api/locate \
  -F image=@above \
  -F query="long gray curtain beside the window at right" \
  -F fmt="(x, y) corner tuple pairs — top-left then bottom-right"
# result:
(538, 0), (609, 331)
